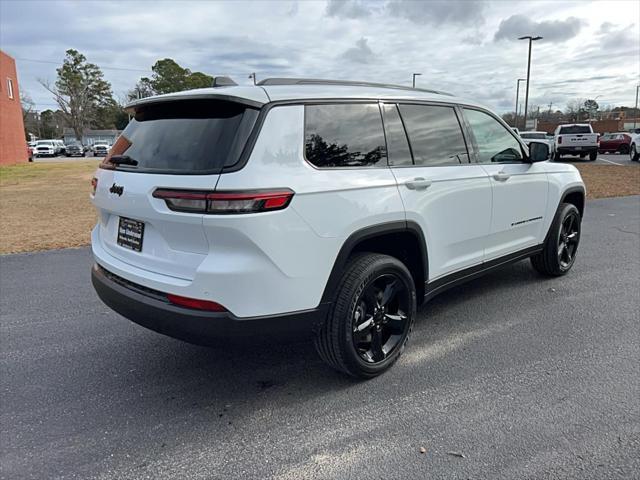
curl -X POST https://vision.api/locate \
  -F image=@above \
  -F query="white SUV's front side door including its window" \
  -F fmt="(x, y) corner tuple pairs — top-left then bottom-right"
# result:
(463, 108), (548, 261)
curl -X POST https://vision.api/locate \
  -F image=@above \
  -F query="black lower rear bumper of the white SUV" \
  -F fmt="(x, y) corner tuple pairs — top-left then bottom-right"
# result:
(91, 264), (328, 345)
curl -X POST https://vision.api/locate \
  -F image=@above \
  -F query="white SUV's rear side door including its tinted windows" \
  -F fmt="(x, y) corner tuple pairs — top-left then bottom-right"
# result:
(382, 103), (491, 281)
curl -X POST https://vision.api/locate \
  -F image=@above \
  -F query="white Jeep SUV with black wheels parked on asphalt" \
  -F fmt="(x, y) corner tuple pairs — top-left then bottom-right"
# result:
(92, 78), (585, 378)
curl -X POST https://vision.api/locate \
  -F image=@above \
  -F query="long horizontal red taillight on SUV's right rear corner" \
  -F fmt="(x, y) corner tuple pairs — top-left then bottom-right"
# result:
(153, 188), (294, 214)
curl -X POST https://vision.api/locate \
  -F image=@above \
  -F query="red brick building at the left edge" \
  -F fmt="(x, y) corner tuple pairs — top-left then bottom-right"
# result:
(0, 50), (28, 165)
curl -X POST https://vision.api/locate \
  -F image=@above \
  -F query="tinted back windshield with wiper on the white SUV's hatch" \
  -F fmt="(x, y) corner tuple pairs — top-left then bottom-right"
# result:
(107, 100), (258, 174)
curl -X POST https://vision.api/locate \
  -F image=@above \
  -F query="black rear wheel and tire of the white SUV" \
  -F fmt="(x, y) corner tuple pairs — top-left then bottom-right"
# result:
(314, 253), (416, 379)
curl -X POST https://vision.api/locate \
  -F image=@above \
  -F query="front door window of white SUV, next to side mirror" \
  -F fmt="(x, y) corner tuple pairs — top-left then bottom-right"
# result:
(464, 108), (523, 163)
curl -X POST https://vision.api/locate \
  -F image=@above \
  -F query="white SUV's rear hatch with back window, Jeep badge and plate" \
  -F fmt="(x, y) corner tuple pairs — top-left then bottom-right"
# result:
(93, 98), (259, 280)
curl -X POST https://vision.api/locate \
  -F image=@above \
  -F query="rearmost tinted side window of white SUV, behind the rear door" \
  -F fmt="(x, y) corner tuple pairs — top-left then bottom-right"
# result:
(304, 103), (387, 168)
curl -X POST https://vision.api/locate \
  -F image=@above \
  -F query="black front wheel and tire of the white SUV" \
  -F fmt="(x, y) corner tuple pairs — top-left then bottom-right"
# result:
(531, 203), (582, 277)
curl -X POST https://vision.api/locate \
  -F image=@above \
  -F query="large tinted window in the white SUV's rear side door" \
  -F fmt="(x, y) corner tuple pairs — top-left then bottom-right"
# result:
(399, 105), (469, 166)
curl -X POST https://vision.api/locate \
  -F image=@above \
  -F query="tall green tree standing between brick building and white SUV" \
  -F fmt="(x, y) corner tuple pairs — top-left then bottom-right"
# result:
(40, 49), (113, 141)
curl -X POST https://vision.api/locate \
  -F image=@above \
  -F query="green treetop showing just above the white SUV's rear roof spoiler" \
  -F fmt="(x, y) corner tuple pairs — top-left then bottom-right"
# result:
(129, 58), (213, 99)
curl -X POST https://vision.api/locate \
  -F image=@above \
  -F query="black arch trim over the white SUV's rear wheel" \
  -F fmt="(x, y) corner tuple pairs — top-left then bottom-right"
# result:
(321, 220), (429, 303)
